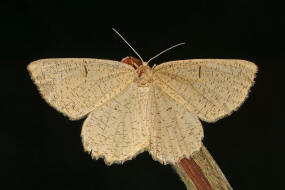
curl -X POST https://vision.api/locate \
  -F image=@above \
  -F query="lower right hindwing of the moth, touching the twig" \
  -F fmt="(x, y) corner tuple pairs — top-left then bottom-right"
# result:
(148, 84), (203, 164)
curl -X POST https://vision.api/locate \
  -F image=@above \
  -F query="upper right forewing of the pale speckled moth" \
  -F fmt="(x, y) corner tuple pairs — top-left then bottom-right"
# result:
(154, 59), (257, 122)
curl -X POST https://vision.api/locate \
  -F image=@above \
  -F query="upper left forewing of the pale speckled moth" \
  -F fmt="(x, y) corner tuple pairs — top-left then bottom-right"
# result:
(28, 58), (135, 120)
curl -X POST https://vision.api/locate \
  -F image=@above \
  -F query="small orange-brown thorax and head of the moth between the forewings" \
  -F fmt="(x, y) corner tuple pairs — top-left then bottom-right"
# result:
(136, 64), (152, 86)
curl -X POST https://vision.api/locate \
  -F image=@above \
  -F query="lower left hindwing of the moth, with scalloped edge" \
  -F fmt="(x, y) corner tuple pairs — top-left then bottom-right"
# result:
(81, 83), (149, 165)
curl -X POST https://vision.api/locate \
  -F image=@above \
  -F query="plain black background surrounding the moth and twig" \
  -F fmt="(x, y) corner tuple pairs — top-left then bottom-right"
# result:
(3, 0), (285, 190)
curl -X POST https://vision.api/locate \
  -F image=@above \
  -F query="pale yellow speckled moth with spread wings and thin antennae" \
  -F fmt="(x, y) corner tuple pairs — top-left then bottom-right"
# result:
(27, 29), (257, 165)
